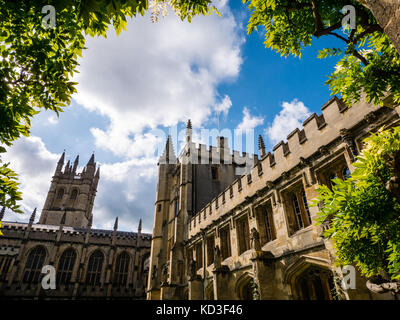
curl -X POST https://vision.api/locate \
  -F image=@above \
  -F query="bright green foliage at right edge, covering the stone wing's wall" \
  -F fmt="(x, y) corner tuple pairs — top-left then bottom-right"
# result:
(316, 127), (400, 281)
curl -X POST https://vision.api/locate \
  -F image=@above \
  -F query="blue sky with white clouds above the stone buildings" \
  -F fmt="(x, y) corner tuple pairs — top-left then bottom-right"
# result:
(1, 0), (342, 233)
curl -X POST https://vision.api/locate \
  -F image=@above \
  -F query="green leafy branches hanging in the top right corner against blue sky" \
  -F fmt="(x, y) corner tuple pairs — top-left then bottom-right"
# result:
(243, 0), (400, 105)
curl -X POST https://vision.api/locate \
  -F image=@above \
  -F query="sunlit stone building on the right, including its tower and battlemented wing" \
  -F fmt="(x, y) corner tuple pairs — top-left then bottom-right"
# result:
(147, 97), (399, 300)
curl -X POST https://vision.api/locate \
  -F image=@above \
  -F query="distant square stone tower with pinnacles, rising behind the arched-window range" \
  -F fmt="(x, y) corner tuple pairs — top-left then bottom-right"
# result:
(39, 152), (100, 228)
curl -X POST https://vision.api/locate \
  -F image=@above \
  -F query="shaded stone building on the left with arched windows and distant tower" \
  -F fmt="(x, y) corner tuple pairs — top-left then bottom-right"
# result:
(0, 153), (151, 299)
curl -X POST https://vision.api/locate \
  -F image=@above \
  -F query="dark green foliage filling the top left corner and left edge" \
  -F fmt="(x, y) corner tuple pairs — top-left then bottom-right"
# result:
(0, 0), (215, 214)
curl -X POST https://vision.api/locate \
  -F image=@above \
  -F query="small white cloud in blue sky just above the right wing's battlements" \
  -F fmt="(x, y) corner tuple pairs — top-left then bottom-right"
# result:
(265, 99), (311, 143)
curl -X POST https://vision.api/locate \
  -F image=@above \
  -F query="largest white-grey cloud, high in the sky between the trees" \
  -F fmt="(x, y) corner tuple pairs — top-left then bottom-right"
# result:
(74, 1), (244, 157)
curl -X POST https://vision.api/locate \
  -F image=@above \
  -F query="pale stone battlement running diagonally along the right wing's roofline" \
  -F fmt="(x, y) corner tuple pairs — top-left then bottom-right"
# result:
(189, 96), (380, 238)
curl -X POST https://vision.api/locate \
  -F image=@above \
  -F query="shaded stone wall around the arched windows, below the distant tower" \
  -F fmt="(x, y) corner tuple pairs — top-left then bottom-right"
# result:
(0, 222), (151, 300)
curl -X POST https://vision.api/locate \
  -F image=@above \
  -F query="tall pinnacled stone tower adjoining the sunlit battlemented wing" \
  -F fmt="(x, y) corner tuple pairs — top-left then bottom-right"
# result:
(147, 120), (246, 300)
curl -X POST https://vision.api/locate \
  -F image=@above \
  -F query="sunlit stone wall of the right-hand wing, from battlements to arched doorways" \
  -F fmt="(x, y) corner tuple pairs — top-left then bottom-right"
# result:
(187, 98), (400, 300)
